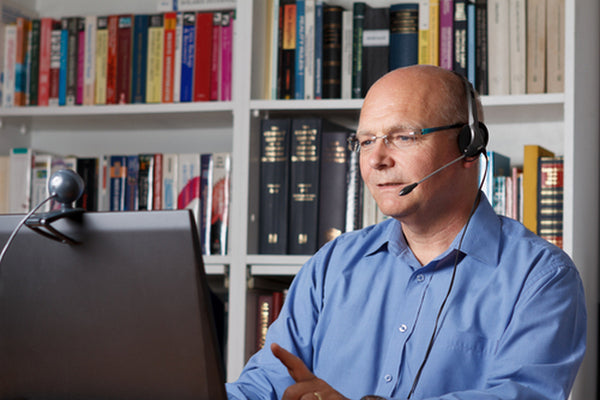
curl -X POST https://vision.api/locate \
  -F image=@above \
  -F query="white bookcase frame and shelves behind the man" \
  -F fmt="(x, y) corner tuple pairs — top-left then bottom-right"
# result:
(0, 0), (600, 400)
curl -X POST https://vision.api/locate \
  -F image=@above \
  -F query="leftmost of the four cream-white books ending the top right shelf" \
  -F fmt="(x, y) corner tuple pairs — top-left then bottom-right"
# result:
(487, 0), (510, 96)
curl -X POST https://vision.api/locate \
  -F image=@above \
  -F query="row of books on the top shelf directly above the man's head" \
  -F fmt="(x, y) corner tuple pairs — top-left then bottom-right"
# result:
(263, 0), (565, 99)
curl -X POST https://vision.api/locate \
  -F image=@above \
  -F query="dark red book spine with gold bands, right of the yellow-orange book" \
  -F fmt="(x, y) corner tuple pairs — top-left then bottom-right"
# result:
(537, 157), (564, 248)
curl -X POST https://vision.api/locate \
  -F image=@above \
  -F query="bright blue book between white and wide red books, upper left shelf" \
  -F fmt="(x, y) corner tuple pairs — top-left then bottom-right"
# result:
(180, 12), (196, 102)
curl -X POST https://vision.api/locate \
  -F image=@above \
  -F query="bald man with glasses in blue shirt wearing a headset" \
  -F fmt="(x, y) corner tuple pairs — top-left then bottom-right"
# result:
(227, 66), (586, 400)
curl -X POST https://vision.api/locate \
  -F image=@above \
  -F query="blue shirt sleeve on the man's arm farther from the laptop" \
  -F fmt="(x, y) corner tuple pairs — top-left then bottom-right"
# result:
(413, 267), (586, 400)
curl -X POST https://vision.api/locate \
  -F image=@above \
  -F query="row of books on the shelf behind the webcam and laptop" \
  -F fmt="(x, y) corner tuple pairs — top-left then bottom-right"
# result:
(0, 148), (231, 255)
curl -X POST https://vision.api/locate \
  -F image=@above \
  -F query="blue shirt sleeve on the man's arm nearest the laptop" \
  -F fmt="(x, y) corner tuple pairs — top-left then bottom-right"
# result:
(226, 245), (327, 400)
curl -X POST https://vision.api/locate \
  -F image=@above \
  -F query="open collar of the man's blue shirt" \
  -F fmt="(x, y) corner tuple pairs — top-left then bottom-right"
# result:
(366, 193), (502, 266)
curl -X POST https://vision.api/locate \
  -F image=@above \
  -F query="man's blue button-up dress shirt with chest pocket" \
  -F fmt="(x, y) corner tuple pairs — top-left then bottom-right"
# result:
(227, 197), (586, 400)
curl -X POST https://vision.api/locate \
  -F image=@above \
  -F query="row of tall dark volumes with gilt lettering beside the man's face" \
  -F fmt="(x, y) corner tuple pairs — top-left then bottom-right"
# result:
(259, 117), (362, 254)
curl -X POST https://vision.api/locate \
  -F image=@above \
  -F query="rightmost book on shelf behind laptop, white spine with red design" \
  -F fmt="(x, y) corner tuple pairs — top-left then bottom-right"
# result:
(210, 153), (231, 256)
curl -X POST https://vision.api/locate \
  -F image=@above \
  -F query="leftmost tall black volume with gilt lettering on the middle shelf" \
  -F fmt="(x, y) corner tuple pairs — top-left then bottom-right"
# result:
(258, 119), (290, 254)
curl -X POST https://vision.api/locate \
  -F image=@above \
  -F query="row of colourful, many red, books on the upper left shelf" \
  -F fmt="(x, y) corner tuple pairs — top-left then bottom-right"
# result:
(0, 11), (235, 107)
